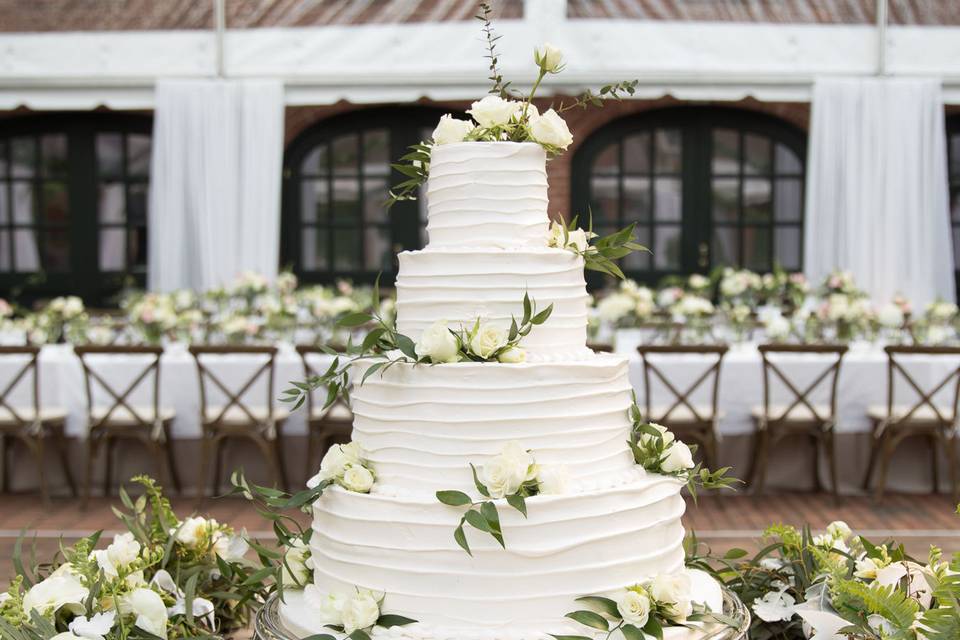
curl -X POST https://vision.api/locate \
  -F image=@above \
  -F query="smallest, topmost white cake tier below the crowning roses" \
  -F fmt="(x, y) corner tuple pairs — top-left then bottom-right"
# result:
(427, 142), (549, 248)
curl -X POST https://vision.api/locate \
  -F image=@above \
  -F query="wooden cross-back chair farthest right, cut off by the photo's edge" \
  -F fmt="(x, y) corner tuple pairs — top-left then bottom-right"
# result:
(863, 346), (960, 502)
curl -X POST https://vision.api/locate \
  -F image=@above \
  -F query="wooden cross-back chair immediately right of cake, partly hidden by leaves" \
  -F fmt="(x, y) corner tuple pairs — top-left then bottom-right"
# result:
(637, 344), (729, 468)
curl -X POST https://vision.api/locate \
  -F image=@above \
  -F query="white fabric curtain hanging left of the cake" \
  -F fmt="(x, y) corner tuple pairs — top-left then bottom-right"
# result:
(148, 80), (284, 291)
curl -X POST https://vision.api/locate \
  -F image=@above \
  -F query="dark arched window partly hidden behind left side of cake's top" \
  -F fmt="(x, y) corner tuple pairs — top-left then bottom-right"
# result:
(281, 107), (454, 283)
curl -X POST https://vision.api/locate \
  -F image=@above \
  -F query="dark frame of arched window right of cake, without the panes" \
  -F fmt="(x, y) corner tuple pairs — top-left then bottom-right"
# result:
(571, 106), (807, 286)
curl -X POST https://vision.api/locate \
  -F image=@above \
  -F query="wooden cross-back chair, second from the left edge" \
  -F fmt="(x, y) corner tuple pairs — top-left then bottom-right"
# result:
(73, 345), (181, 505)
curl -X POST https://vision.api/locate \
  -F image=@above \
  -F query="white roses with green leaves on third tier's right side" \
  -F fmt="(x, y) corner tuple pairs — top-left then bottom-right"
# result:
(627, 397), (742, 501)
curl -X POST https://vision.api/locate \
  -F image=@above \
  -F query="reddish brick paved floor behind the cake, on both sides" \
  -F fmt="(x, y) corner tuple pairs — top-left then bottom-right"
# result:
(0, 493), (960, 584)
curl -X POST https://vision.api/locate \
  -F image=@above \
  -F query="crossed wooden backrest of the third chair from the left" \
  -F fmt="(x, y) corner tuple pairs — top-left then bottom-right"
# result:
(190, 345), (277, 423)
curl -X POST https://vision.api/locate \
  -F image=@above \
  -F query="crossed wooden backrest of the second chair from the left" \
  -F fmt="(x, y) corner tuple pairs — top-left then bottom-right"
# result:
(73, 345), (163, 430)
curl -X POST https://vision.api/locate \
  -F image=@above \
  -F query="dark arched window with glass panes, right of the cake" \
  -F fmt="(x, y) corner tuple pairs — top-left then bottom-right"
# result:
(572, 107), (806, 282)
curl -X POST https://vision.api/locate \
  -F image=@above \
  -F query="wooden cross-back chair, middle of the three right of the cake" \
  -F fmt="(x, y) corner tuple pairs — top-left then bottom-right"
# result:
(748, 343), (847, 497)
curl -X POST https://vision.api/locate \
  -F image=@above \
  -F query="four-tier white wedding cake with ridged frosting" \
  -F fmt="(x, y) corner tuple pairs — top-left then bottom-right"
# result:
(281, 141), (721, 640)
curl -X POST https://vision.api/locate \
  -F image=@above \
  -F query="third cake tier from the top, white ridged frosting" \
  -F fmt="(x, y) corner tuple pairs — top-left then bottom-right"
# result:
(352, 354), (635, 496)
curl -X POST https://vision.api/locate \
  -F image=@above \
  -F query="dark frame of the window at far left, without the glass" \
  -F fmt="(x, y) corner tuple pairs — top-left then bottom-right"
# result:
(0, 112), (153, 305)
